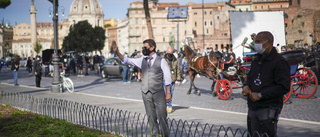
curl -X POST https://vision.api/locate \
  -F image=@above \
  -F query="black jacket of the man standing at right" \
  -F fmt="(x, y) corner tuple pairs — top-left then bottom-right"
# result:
(244, 48), (291, 110)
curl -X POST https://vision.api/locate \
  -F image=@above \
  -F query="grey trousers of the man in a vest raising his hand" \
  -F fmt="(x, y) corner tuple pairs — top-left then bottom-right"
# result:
(142, 91), (169, 137)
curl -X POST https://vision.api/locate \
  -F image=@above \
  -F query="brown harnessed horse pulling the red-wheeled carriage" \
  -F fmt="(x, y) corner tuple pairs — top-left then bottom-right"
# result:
(184, 45), (221, 96)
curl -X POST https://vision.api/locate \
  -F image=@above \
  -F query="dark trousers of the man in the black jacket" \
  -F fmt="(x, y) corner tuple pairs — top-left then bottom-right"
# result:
(247, 108), (281, 137)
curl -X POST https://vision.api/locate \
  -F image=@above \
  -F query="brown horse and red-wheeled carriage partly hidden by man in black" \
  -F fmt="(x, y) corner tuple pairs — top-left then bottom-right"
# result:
(185, 42), (319, 102)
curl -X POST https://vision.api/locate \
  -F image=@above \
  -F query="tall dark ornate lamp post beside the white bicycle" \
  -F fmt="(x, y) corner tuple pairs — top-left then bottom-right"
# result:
(49, 0), (64, 93)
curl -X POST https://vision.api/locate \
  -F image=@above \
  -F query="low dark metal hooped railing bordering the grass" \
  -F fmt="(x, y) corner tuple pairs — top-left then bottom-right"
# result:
(0, 91), (268, 137)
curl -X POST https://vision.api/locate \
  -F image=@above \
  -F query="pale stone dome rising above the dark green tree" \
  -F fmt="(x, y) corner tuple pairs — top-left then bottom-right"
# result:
(69, 0), (104, 28)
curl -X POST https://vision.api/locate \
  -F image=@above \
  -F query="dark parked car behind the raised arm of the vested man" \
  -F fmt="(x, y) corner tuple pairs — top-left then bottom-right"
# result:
(100, 57), (123, 78)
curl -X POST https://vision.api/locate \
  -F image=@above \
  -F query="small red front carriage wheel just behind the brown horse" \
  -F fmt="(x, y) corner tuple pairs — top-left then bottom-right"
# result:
(217, 79), (232, 100)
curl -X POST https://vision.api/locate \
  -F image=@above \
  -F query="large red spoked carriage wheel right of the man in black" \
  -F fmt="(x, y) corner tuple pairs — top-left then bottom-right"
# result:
(291, 68), (318, 98)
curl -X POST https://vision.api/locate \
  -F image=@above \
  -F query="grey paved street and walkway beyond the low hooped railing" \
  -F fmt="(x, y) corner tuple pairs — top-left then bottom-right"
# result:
(0, 68), (320, 136)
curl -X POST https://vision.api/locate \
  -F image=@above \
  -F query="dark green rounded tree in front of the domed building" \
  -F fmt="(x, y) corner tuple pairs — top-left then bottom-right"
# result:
(62, 21), (106, 52)
